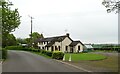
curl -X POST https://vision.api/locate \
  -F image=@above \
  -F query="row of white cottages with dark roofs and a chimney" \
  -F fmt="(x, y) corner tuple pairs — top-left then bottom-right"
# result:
(36, 33), (84, 53)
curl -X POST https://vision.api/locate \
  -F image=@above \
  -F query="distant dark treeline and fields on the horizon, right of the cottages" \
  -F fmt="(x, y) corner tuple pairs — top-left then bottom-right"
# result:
(92, 44), (120, 52)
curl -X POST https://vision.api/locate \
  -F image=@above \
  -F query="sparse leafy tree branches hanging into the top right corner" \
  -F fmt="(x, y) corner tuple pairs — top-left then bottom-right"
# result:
(102, 0), (120, 13)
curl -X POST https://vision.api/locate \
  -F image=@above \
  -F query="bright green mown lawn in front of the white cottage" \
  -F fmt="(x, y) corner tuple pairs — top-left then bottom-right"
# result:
(65, 53), (107, 61)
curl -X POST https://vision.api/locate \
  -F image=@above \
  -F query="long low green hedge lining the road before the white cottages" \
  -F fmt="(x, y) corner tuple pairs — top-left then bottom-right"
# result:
(6, 46), (64, 60)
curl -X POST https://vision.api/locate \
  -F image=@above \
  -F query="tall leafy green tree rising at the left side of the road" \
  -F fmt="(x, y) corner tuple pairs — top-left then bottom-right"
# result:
(0, 2), (21, 47)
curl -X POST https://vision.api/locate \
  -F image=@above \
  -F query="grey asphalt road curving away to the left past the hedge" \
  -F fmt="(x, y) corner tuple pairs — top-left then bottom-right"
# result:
(2, 50), (84, 72)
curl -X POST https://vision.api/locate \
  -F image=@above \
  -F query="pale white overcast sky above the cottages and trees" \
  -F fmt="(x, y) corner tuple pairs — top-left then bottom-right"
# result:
(10, 0), (118, 43)
